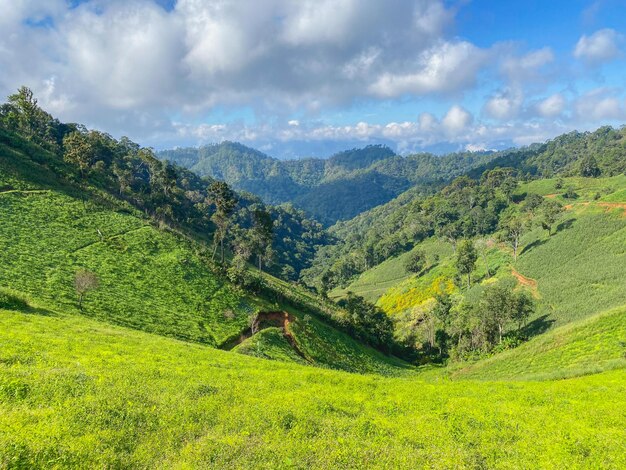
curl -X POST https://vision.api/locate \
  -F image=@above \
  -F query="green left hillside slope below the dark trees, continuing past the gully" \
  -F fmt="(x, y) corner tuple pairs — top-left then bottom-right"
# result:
(0, 126), (406, 373)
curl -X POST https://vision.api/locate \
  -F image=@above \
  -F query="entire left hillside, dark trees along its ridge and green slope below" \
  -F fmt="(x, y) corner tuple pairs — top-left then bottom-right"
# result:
(0, 89), (406, 373)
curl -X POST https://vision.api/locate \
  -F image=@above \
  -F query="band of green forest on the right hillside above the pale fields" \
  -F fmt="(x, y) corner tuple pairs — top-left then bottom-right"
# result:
(304, 127), (626, 285)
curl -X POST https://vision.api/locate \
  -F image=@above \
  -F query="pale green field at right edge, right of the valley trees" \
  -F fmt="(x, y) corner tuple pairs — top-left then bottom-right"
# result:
(516, 205), (626, 326)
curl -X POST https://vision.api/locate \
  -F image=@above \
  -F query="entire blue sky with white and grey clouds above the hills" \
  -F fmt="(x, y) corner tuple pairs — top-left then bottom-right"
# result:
(0, 0), (626, 158)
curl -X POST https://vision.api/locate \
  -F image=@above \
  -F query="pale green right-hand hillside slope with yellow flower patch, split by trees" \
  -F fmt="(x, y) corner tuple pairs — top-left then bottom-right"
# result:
(332, 175), (626, 326)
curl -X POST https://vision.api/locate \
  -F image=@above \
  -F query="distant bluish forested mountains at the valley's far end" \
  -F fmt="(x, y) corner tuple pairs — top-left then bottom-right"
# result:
(158, 142), (496, 225)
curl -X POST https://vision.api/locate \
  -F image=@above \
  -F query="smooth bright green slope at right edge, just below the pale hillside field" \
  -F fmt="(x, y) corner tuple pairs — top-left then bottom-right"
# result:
(451, 307), (626, 380)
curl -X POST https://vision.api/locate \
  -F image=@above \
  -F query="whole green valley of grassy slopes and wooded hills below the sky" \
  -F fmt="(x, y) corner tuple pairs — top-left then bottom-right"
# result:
(0, 90), (626, 468)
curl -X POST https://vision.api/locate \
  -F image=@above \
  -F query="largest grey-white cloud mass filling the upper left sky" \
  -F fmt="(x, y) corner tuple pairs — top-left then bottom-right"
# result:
(0, 0), (464, 123)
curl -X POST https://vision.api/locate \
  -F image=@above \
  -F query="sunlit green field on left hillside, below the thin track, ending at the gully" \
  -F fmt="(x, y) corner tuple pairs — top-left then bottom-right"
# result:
(0, 191), (261, 345)
